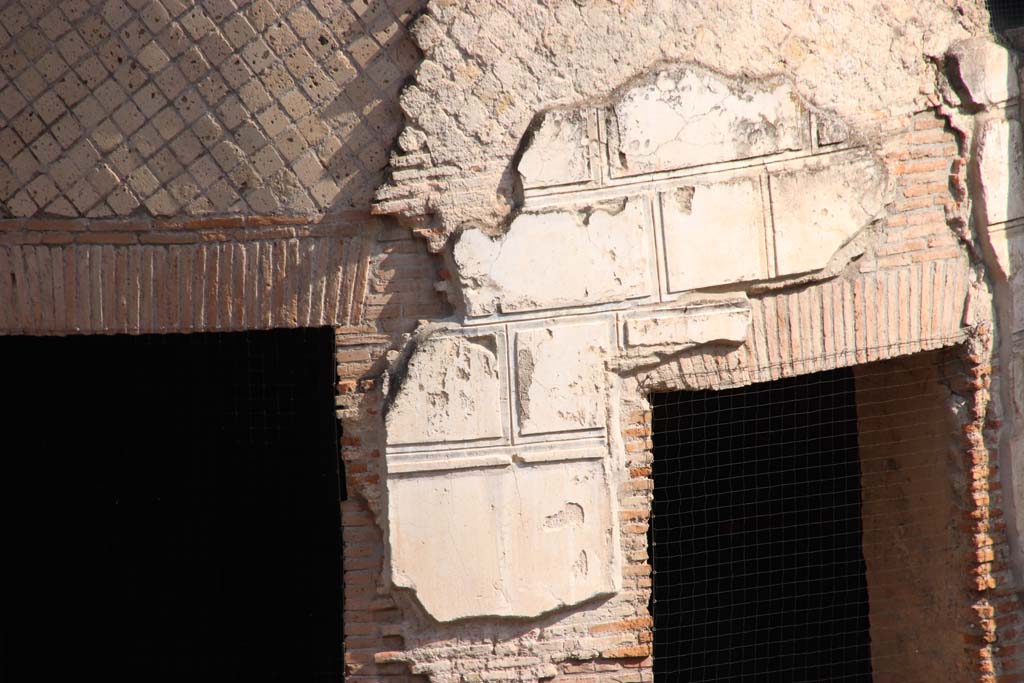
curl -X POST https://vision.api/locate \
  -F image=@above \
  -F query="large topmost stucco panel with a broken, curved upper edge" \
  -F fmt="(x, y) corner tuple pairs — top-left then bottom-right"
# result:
(609, 67), (807, 175)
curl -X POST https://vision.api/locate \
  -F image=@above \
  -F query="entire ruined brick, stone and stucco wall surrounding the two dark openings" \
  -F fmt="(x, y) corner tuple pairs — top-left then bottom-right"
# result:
(0, 0), (1024, 683)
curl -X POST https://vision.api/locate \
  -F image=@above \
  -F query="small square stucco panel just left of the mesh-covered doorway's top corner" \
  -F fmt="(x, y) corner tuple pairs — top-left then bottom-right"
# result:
(514, 322), (611, 434)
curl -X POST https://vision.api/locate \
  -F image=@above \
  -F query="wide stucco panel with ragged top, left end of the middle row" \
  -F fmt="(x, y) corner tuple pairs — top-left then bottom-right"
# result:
(454, 199), (651, 315)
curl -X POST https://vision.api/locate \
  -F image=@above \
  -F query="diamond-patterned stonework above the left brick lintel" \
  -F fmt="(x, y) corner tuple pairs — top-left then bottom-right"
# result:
(0, 0), (423, 217)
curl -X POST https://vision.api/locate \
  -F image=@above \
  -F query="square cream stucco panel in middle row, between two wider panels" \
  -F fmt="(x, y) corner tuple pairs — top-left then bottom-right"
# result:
(659, 176), (769, 292)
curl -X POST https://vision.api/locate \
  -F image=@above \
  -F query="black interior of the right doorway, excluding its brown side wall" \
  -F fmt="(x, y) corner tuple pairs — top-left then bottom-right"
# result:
(649, 370), (871, 683)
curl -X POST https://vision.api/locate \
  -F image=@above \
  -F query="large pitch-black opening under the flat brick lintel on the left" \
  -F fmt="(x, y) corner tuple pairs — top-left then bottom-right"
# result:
(0, 329), (344, 683)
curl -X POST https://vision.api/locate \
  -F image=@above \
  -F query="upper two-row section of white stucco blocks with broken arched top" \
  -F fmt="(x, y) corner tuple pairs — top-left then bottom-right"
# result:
(452, 65), (893, 317)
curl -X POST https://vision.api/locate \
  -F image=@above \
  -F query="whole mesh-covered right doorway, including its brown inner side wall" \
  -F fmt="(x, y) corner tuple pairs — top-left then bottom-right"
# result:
(649, 355), (969, 683)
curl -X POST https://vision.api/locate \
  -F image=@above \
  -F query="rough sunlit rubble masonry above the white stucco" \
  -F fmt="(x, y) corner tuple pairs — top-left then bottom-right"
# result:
(377, 0), (987, 242)
